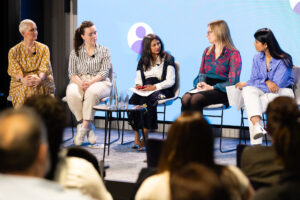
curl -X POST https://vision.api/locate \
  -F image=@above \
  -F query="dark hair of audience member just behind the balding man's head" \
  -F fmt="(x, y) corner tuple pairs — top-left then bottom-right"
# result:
(24, 95), (66, 180)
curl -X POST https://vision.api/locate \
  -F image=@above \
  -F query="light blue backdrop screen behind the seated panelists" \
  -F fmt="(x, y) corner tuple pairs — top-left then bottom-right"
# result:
(78, 0), (300, 126)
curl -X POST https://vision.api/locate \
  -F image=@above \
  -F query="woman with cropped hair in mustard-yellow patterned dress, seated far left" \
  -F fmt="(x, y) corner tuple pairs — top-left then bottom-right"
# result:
(8, 19), (55, 108)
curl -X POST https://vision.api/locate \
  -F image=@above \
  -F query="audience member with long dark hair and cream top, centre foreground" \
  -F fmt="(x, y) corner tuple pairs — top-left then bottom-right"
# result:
(135, 112), (253, 200)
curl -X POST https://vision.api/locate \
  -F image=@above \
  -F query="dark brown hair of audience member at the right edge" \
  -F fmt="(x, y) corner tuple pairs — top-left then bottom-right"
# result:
(266, 97), (300, 172)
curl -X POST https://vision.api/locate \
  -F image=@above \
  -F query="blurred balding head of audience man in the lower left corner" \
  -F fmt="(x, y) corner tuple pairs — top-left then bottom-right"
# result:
(0, 107), (49, 177)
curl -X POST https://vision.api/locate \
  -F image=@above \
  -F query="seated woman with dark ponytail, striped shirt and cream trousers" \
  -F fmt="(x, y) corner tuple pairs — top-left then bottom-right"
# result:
(66, 21), (111, 145)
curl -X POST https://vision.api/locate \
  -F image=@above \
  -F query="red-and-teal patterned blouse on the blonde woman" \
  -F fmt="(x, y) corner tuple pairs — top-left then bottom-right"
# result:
(194, 46), (242, 92)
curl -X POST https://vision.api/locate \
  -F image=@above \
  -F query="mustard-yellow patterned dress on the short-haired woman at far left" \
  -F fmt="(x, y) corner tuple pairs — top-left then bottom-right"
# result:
(8, 41), (54, 108)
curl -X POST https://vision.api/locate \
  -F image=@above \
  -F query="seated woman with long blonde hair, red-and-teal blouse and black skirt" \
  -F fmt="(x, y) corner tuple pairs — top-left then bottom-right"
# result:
(181, 20), (242, 112)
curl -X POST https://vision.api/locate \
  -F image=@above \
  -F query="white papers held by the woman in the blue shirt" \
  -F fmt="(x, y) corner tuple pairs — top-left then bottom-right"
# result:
(226, 85), (244, 110)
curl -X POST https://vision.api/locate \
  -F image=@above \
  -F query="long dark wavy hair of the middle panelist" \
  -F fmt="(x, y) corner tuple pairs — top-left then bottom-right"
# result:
(139, 33), (171, 71)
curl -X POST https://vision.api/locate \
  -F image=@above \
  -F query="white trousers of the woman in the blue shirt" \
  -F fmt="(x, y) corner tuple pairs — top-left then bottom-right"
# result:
(242, 86), (294, 145)
